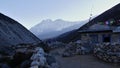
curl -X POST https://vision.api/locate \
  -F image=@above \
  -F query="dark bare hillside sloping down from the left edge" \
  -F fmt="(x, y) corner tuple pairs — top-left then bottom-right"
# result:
(0, 13), (40, 45)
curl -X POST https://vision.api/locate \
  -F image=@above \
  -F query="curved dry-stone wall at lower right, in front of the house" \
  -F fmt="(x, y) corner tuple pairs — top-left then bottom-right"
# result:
(94, 43), (120, 63)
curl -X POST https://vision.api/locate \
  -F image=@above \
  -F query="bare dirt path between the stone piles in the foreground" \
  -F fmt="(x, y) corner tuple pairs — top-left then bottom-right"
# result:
(49, 49), (120, 68)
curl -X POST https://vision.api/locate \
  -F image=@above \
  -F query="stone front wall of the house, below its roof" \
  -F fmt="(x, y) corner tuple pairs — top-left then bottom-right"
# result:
(81, 33), (120, 44)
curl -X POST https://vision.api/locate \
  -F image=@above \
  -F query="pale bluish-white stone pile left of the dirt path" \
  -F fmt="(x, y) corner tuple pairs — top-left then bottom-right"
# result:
(30, 47), (59, 68)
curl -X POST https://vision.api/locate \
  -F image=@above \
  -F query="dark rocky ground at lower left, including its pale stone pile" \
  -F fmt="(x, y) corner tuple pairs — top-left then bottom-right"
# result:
(0, 43), (57, 68)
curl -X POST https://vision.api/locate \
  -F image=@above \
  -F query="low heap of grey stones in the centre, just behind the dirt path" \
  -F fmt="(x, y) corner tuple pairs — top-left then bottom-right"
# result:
(63, 42), (89, 57)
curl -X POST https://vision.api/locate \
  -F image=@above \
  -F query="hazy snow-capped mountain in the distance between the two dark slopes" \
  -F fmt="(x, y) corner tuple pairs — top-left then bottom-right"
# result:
(30, 19), (87, 39)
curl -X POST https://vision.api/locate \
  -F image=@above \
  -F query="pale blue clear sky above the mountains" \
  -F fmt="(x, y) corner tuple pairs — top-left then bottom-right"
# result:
(0, 0), (120, 29)
